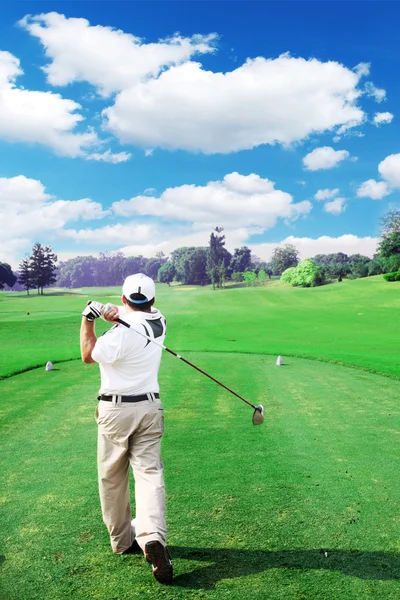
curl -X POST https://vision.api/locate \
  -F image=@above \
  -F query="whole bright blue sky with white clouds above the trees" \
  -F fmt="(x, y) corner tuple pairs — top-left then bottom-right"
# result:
(0, 0), (400, 267)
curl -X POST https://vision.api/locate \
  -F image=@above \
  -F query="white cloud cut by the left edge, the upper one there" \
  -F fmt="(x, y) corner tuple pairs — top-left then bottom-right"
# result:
(0, 51), (98, 157)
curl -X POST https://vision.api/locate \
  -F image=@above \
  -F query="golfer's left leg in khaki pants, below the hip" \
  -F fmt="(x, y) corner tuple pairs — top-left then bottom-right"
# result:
(97, 414), (134, 554)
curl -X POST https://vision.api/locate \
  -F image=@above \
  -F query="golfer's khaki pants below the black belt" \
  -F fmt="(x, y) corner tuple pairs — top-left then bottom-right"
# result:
(96, 399), (167, 554)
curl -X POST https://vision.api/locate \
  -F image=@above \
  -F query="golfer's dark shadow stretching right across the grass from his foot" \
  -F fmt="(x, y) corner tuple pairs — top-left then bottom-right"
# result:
(169, 546), (400, 589)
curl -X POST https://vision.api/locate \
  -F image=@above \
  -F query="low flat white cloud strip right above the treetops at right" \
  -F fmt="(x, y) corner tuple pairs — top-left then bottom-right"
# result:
(247, 234), (379, 260)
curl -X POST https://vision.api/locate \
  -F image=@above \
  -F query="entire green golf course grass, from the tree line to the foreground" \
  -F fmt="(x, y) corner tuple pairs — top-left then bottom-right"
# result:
(0, 277), (400, 600)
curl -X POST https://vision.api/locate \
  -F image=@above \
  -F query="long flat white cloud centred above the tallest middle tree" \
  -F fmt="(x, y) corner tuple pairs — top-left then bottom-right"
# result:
(112, 172), (312, 229)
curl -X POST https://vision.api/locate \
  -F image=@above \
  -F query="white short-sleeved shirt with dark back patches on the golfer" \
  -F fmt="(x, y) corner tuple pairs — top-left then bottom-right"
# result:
(92, 308), (166, 396)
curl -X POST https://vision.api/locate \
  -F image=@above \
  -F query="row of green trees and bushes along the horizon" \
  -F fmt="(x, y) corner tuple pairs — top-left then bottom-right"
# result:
(0, 209), (400, 294)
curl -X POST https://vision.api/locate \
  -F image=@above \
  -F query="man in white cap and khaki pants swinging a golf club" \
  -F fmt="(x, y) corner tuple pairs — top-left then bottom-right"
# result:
(80, 273), (173, 583)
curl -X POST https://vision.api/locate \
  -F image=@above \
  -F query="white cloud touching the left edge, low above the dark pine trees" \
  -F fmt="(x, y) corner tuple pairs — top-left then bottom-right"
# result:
(0, 175), (108, 244)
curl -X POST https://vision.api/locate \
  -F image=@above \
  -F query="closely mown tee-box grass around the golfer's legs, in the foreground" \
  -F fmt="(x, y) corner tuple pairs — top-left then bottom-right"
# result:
(0, 353), (400, 600)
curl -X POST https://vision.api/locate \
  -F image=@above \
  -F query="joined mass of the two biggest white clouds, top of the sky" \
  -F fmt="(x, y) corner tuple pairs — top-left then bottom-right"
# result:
(14, 12), (385, 156)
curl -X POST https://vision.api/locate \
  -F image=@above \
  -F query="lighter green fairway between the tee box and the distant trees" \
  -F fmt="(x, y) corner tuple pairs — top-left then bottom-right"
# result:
(0, 276), (400, 378)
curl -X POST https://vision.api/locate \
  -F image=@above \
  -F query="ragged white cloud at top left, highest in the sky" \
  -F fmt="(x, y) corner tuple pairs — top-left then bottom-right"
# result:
(20, 12), (217, 96)
